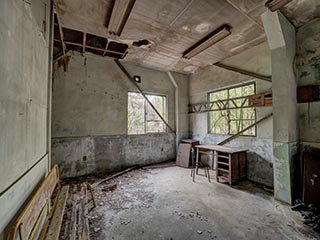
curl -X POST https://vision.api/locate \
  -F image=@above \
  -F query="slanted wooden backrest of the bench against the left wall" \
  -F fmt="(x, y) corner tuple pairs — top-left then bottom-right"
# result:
(13, 165), (59, 239)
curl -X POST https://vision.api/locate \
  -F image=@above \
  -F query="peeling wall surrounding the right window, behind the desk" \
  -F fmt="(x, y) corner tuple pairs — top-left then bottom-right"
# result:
(189, 43), (273, 186)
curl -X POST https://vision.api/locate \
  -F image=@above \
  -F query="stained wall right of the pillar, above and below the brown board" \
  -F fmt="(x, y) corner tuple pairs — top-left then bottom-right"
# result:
(296, 19), (320, 144)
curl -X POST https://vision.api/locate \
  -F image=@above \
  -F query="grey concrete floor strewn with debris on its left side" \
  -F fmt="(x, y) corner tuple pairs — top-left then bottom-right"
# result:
(89, 167), (320, 240)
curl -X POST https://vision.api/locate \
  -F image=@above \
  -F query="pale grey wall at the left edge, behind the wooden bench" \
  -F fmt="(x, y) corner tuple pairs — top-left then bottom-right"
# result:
(0, 0), (50, 236)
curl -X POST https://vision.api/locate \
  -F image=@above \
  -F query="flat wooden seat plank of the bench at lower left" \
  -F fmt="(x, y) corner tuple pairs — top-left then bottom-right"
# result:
(47, 185), (69, 240)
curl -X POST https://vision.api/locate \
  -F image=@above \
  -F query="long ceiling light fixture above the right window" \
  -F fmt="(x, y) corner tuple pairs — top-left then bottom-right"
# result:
(182, 24), (231, 59)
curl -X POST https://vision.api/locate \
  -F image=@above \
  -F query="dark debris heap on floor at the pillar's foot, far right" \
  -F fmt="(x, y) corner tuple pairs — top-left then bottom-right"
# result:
(291, 199), (320, 232)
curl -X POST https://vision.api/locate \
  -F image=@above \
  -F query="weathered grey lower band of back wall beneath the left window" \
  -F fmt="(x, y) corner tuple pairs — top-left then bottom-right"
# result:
(52, 133), (176, 178)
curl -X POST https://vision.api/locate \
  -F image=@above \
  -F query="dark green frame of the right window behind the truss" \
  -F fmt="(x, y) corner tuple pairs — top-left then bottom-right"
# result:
(207, 81), (257, 137)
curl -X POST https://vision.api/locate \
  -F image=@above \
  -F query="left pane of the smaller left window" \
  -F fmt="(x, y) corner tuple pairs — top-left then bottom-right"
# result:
(128, 93), (145, 134)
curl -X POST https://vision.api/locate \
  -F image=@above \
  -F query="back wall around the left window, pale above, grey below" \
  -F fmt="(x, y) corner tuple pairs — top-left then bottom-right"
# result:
(52, 53), (188, 177)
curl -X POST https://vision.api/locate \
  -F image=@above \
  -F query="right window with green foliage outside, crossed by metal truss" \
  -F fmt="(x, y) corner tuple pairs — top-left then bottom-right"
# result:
(208, 83), (256, 136)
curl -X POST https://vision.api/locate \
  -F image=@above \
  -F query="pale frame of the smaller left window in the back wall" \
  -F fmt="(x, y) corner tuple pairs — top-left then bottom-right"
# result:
(126, 91), (169, 136)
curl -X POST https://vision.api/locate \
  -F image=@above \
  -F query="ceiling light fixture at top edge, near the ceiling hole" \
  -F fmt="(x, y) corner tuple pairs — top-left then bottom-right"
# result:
(108, 0), (136, 36)
